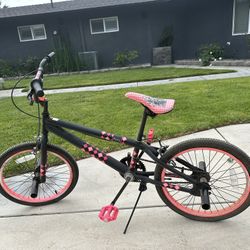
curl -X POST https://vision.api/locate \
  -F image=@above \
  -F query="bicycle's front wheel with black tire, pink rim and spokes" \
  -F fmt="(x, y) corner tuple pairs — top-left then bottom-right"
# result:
(0, 143), (79, 206)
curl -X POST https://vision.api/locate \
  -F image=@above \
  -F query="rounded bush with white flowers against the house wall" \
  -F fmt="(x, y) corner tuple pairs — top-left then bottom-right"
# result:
(198, 43), (224, 66)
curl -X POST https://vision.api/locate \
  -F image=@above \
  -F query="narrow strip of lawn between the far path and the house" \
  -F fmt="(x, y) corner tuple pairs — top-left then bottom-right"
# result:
(1, 67), (234, 89)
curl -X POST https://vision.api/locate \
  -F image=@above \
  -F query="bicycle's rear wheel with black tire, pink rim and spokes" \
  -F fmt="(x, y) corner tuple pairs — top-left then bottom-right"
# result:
(155, 139), (250, 221)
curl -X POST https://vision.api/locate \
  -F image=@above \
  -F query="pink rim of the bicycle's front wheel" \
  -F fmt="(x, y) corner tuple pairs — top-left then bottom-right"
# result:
(0, 150), (73, 203)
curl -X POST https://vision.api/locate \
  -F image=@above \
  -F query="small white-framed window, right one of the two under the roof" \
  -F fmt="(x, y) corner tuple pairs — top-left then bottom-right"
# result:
(90, 17), (119, 34)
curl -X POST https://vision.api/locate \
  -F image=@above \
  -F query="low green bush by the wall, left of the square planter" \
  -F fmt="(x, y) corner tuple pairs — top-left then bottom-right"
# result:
(113, 50), (139, 67)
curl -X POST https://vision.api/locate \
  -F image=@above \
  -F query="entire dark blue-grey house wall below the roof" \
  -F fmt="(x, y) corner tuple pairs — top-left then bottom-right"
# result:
(0, 0), (249, 67)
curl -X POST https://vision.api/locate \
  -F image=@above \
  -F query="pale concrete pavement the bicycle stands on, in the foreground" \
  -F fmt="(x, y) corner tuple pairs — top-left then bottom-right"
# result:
(0, 124), (250, 250)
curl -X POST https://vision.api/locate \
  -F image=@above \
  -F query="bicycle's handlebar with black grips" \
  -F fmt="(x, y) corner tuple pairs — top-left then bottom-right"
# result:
(28, 52), (55, 100)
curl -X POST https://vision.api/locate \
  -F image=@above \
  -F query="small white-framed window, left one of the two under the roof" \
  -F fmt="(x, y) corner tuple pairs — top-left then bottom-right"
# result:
(17, 24), (47, 42)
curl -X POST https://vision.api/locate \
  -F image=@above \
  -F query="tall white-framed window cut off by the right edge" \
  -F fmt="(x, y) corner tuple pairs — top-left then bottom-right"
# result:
(233, 0), (250, 35)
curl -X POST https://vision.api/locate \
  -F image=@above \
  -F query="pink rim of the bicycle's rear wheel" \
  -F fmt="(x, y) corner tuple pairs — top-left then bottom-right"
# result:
(161, 147), (250, 218)
